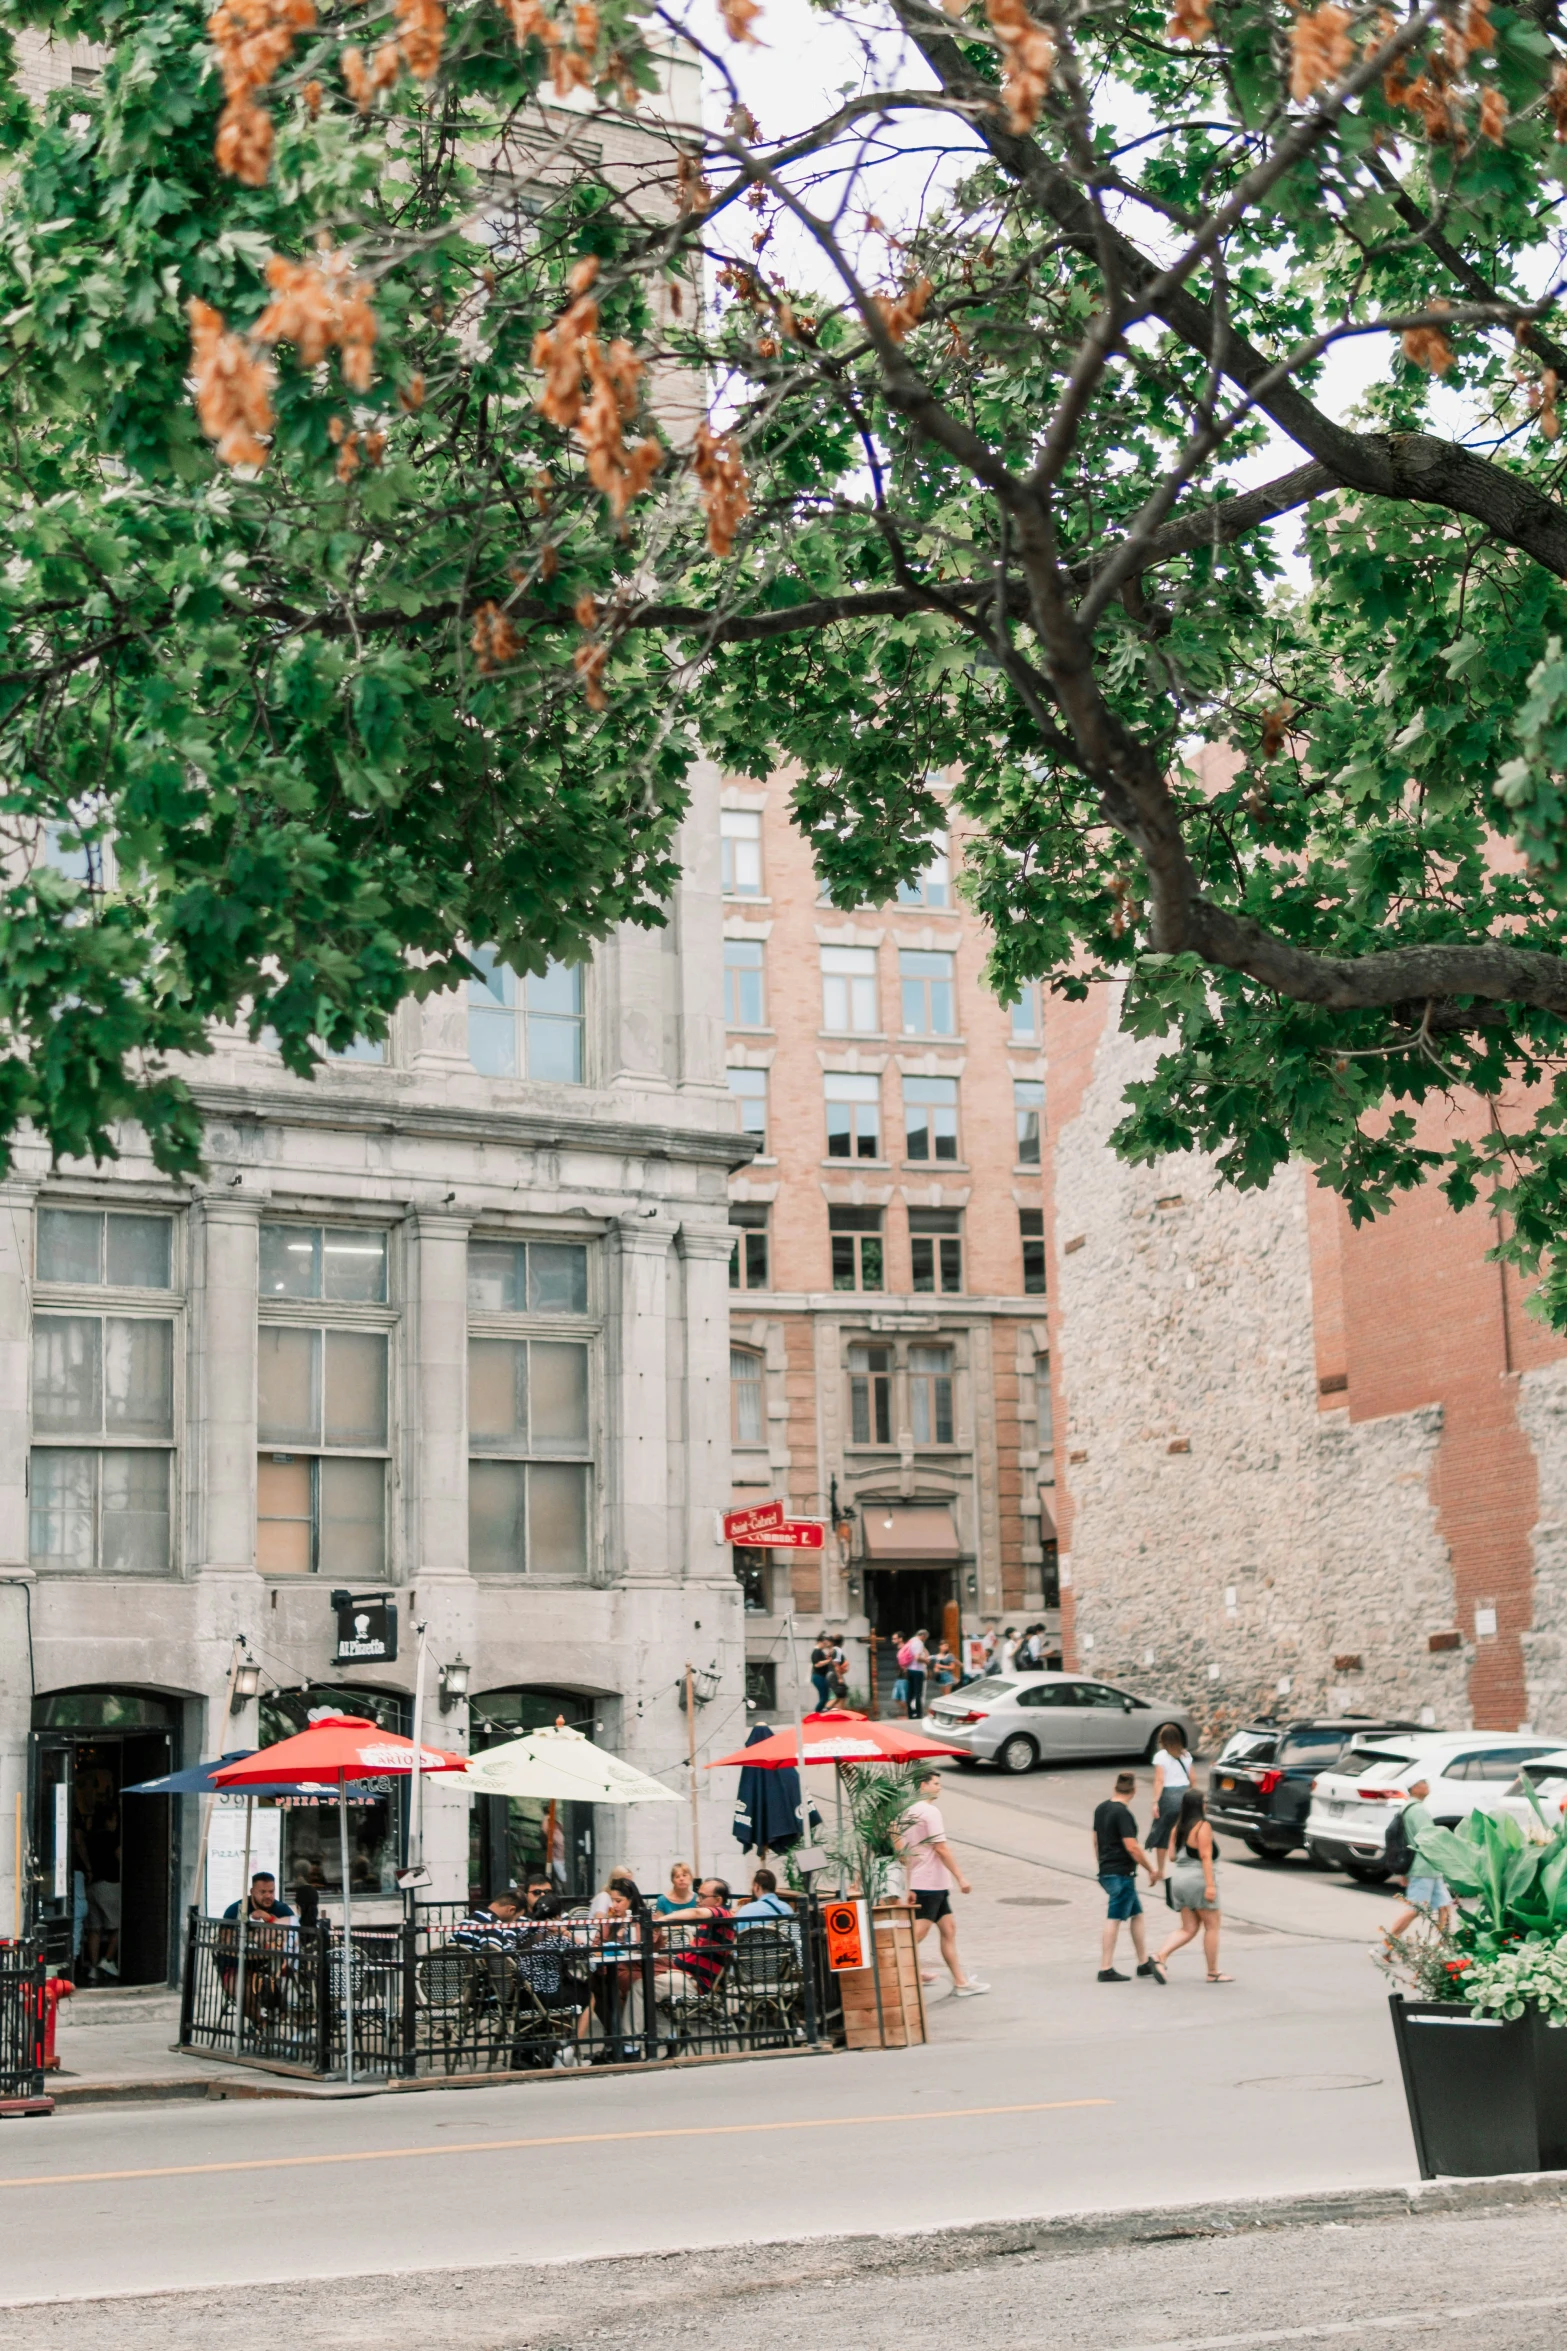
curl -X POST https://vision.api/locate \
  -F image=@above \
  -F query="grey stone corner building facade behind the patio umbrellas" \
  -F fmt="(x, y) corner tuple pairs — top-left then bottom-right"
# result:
(0, 771), (749, 1980)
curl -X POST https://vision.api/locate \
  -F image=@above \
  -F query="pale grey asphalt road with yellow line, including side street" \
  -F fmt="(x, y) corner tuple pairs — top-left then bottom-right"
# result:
(0, 1768), (1447, 2313)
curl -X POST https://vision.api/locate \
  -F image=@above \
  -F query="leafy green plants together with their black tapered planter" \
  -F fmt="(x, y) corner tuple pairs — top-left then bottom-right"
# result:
(1386, 1813), (1567, 2179)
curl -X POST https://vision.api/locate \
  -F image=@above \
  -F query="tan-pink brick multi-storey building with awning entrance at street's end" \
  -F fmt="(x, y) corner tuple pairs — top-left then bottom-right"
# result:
(721, 778), (1057, 1704)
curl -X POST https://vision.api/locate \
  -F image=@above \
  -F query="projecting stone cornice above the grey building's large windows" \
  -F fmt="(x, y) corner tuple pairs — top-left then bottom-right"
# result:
(193, 1086), (756, 1168)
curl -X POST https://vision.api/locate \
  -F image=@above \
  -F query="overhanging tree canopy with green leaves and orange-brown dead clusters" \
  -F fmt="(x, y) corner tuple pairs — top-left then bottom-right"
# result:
(0, 0), (1567, 1321)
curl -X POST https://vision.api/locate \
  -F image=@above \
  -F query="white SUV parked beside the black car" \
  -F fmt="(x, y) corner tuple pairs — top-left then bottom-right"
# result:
(1306, 1730), (1562, 1878)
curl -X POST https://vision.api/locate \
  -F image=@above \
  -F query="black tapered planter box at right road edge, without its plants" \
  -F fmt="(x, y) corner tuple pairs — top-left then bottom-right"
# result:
(1388, 1994), (1567, 2179)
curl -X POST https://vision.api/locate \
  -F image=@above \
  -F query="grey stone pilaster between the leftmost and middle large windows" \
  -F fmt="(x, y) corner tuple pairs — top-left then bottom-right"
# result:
(186, 1192), (261, 1573)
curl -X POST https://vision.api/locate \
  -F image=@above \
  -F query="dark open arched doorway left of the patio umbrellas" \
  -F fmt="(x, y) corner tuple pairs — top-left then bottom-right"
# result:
(31, 1688), (181, 1987)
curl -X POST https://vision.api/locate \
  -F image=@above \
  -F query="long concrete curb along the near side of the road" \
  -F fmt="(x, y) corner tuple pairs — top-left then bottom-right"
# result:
(0, 2172), (1567, 2323)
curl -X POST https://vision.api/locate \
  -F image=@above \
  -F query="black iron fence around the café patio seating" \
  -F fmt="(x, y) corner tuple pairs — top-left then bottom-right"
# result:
(179, 1902), (841, 2076)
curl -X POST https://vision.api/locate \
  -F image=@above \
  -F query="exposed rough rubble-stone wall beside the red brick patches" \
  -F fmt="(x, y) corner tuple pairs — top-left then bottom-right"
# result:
(1055, 992), (1475, 1740)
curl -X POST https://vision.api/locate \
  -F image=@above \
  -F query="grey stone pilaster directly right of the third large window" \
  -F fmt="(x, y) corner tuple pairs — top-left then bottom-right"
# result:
(599, 1215), (677, 1582)
